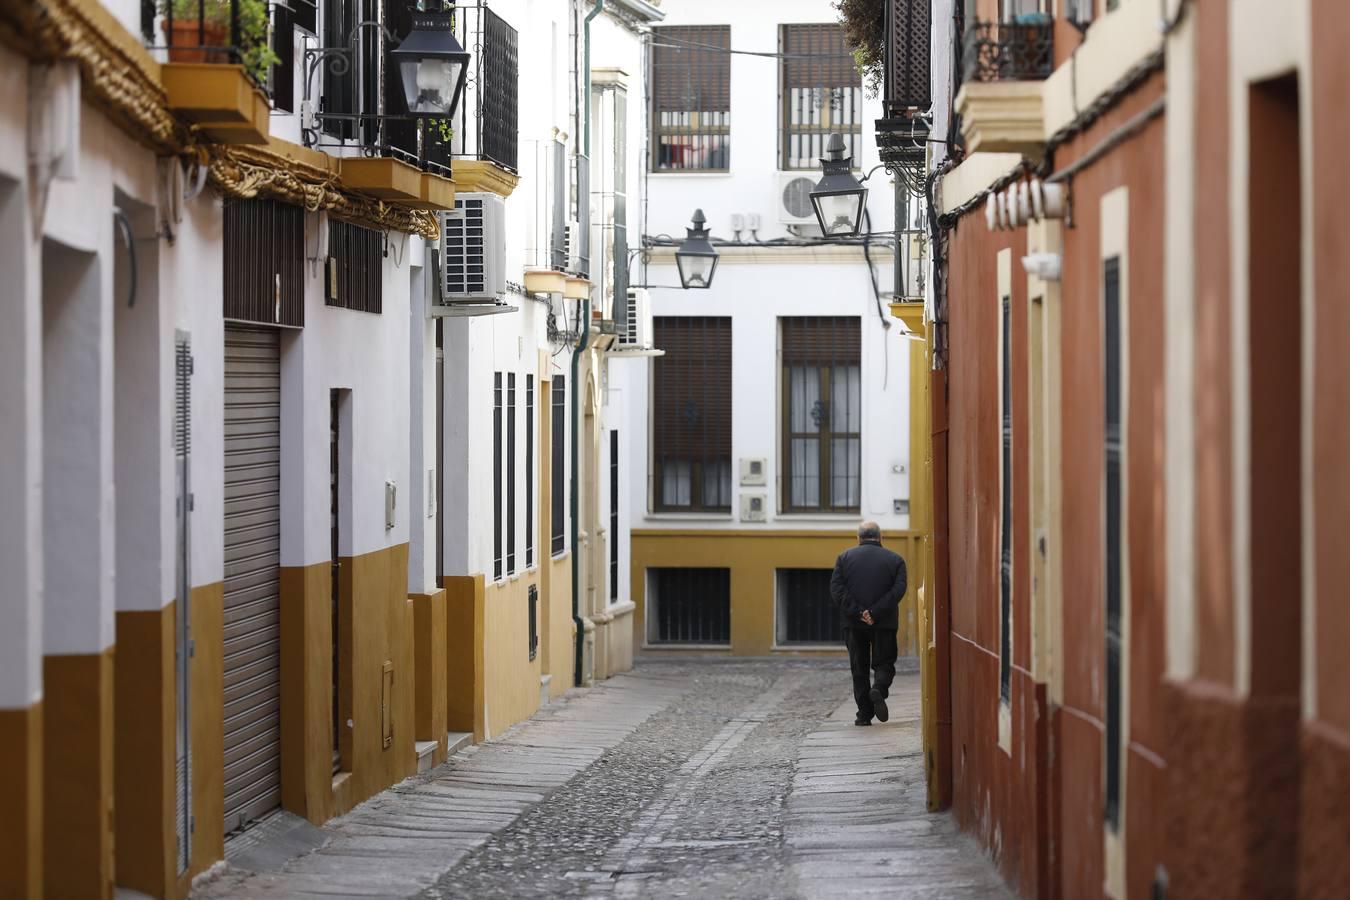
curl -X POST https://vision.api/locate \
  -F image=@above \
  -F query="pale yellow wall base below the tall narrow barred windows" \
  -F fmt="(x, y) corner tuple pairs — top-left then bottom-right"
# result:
(483, 571), (544, 738)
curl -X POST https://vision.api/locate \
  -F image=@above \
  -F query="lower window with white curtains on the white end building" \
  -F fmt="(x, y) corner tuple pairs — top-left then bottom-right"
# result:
(779, 316), (863, 513)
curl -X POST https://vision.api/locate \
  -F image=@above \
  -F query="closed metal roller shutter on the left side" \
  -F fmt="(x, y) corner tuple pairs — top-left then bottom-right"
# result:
(224, 327), (281, 833)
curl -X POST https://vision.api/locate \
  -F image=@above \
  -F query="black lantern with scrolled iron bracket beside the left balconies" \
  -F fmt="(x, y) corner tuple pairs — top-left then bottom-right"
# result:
(301, 12), (470, 146)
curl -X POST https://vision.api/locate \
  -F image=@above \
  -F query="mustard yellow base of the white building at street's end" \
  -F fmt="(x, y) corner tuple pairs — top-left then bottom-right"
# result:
(632, 528), (923, 656)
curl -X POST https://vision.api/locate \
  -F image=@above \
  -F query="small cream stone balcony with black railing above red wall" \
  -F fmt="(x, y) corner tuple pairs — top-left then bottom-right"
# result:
(956, 15), (1054, 157)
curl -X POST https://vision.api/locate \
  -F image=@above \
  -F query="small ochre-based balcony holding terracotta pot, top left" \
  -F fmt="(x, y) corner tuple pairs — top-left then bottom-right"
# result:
(140, 0), (272, 144)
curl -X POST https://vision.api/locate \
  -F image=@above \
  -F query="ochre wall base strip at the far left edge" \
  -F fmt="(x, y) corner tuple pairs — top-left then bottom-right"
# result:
(0, 702), (43, 900)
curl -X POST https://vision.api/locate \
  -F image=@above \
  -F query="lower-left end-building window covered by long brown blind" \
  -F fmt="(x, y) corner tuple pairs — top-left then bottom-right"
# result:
(652, 316), (732, 513)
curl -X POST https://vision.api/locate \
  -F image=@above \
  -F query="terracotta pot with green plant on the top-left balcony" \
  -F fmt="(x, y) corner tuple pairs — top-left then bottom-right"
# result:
(161, 0), (281, 85)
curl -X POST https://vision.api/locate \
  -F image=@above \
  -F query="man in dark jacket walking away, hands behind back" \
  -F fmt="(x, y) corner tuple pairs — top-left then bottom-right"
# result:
(830, 522), (905, 725)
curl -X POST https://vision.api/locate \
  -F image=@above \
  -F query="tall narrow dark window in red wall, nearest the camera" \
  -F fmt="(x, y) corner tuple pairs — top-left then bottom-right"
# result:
(1102, 256), (1125, 831)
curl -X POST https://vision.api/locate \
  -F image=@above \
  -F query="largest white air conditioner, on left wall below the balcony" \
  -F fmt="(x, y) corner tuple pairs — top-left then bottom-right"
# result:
(440, 193), (506, 305)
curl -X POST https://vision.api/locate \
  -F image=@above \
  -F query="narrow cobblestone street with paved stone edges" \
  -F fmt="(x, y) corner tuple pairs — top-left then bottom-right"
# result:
(197, 660), (1007, 899)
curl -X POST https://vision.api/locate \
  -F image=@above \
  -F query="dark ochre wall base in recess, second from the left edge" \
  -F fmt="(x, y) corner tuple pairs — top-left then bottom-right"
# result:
(42, 648), (113, 897)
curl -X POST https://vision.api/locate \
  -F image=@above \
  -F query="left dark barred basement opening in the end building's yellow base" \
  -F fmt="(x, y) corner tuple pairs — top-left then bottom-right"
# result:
(647, 568), (732, 644)
